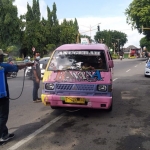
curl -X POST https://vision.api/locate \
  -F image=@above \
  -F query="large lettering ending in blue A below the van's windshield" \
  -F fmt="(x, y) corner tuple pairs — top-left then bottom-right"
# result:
(55, 70), (104, 82)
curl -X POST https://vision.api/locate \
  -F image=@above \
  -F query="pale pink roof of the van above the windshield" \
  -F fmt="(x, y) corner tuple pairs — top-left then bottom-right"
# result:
(56, 44), (108, 51)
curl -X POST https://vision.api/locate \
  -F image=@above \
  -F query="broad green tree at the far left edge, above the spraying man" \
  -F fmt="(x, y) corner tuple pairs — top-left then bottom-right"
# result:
(0, 0), (20, 49)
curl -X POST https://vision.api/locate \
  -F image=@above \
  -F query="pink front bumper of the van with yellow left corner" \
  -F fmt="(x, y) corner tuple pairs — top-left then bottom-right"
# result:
(41, 94), (112, 109)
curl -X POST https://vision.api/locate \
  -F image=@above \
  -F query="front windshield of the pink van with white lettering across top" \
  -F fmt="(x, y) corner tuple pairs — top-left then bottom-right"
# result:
(48, 50), (108, 71)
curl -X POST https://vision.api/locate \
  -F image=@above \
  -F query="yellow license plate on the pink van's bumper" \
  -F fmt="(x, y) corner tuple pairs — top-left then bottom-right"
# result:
(65, 97), (85, 104)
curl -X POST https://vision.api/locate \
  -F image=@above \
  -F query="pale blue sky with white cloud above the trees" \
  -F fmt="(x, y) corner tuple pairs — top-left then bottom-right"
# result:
(14, 0), (144, 48)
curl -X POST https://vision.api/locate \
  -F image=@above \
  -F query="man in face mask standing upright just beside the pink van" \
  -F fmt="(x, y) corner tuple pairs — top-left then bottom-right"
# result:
(32, 52), (41, 103)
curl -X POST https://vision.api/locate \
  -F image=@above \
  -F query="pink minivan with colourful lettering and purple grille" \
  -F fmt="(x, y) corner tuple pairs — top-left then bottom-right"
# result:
(41, 44), (114, 111)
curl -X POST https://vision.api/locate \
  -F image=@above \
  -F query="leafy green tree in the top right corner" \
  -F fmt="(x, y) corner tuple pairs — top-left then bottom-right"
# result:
(125, 0), (150, 39)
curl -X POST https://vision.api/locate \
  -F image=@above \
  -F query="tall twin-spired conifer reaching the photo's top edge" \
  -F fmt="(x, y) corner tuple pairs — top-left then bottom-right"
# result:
(24, 0), (44, 55)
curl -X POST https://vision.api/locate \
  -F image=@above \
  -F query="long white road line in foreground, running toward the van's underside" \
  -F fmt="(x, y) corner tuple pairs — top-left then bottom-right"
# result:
(7, 114), (63, 150)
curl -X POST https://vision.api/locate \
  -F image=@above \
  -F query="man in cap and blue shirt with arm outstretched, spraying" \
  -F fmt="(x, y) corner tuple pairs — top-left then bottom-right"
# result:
(0, 49), (33, 145)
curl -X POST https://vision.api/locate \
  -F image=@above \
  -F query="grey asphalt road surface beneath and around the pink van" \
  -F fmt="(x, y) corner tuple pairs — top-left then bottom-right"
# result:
(0, 59), (150, 150)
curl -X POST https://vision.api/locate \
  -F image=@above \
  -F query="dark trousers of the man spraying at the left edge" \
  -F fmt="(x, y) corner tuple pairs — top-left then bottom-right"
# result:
(0, 98), (9, 138)
